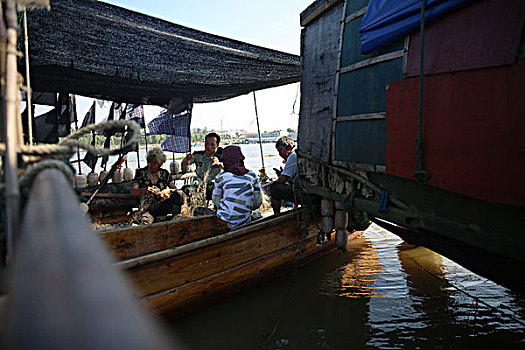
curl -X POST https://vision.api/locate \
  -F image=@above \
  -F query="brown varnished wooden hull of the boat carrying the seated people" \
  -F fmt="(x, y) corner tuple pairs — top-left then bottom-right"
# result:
(99, 209), (335, 316)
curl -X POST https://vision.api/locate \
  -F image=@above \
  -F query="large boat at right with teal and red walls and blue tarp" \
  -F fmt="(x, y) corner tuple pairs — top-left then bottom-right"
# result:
(298, 0), (525, 291)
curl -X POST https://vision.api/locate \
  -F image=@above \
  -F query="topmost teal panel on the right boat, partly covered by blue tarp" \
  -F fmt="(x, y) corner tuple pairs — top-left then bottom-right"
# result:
(341, 16), (405, 67)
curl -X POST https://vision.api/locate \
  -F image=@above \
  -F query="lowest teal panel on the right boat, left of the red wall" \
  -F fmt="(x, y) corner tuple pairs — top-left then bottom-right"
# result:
(335, 119), (386, 165)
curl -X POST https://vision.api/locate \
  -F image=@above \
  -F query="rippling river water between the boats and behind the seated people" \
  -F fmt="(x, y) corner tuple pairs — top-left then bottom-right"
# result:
(79, 144), (525, 349)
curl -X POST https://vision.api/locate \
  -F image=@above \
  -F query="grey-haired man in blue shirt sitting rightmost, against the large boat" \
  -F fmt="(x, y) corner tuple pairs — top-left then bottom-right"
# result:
(270, 136), (298, 214)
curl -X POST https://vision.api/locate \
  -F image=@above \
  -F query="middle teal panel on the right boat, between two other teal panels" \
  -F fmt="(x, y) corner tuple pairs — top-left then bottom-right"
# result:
(337, 58), (403, 117)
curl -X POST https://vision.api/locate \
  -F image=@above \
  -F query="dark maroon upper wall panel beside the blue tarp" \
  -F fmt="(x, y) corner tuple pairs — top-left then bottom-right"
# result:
(406, 0), (525, 76)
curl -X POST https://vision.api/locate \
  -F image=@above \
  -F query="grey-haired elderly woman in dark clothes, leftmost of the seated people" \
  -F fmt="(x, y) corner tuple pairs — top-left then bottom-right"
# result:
(131, 147), (184, 224)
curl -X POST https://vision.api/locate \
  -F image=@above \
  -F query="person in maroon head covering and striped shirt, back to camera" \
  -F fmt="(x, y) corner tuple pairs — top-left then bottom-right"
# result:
(212, 146), (262, 228)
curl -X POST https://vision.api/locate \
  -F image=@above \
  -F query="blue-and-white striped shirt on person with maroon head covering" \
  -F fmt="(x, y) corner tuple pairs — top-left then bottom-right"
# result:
(213, 170), (261, 228)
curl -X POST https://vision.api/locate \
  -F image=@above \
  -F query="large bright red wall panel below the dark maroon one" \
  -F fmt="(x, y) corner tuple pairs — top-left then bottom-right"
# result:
(386, 59), (525, 206)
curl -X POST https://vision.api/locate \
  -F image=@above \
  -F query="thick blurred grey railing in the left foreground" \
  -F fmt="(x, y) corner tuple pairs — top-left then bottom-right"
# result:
(3, 169), (180, 349)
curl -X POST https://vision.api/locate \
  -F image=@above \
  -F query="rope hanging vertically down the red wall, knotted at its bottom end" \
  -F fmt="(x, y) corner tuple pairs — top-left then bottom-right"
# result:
(412, 0), (430, 182)
